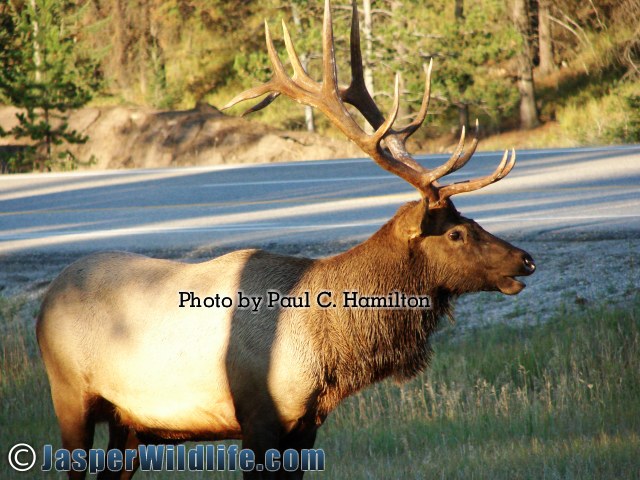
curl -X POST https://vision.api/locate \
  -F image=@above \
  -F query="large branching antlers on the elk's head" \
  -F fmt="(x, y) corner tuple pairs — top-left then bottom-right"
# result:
(223, 0), (516, 208)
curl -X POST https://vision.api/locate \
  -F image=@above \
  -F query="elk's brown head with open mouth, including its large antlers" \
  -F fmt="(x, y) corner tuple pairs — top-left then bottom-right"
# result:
(223, 0), (535, 295)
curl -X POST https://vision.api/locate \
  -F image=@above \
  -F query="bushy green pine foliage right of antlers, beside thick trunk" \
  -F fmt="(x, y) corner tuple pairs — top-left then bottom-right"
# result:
(419, 0), (517, 128)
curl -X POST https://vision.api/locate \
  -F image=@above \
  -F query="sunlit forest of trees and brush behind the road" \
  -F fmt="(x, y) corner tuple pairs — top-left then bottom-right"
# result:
(0, 0), (640, 171)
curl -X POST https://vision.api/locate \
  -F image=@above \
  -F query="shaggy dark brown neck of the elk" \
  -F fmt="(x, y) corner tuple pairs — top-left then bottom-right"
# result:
(302, 212), (450, 411)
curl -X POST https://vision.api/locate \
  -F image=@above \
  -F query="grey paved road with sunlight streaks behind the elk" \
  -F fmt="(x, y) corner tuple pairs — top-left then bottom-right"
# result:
(0, 145), (640, 254)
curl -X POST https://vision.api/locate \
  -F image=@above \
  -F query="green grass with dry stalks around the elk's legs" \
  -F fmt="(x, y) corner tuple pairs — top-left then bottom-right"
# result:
(0, 297), (640, 480)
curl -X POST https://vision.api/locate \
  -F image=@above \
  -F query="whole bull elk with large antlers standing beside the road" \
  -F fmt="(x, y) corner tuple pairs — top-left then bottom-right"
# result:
(37, 0), (535, 478)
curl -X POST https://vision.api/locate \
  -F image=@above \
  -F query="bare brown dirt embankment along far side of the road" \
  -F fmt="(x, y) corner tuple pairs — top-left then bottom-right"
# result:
(0, 104), (362, 169)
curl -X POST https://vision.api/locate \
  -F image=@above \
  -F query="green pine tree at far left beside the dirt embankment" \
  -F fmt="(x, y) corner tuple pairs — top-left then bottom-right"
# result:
(0, 0), (98, 170)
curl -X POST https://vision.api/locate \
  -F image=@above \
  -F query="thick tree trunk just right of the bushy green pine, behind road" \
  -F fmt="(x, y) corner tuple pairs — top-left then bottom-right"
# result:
(513, 0), (540, 129)
